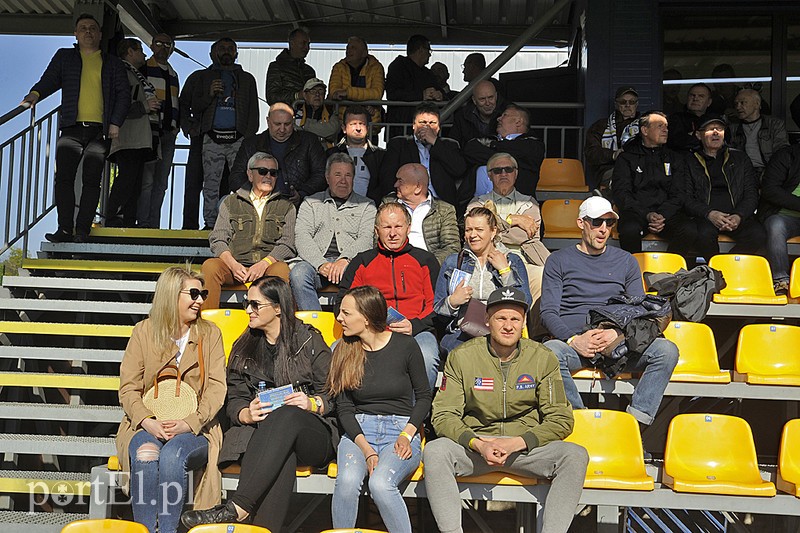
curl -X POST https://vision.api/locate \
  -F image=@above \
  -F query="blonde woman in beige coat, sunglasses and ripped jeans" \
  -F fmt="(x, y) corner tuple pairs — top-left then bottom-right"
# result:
(117, 267), (227, 533)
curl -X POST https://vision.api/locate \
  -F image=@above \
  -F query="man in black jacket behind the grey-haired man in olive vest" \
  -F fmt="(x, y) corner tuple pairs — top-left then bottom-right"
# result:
(230, 102), (327, 206)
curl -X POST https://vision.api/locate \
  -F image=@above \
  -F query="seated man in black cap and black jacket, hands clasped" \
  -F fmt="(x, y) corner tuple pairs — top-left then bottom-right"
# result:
(670, 116), (766, 261)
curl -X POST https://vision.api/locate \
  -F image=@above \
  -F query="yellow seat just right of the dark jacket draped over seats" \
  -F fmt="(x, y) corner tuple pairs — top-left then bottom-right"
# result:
(708, 254), (788, 305)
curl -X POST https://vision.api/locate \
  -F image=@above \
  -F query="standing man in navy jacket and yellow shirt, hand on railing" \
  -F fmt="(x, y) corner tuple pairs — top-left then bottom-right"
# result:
(22, 14), (131, 242)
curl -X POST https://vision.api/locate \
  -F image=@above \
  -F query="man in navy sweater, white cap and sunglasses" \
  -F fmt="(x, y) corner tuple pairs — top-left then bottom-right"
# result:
(541, 196), (678, 425)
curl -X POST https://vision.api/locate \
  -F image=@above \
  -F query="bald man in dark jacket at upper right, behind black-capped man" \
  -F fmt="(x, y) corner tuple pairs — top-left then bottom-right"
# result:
(731, 89), (789, 172)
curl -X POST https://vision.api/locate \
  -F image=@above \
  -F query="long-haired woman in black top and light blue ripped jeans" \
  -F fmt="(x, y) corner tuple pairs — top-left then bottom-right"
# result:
(328, 286), (431, 533)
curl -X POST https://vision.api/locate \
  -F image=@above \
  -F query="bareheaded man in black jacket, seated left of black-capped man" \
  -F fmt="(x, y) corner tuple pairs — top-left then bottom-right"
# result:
(611, 111), (681, 253)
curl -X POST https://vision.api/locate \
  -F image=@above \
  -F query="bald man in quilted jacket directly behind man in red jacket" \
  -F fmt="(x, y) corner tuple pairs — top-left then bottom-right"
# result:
(381, 163), (461, 265)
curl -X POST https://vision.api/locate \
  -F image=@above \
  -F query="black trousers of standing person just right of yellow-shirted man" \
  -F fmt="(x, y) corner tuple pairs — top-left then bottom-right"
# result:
(105, 148), (153, 228)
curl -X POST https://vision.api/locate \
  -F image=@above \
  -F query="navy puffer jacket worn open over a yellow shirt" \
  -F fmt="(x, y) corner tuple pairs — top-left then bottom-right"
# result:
(31, 44), (131, 134)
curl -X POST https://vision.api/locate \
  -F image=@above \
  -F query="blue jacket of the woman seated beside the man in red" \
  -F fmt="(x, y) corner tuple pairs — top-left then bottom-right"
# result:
(433, 249), (533, 331)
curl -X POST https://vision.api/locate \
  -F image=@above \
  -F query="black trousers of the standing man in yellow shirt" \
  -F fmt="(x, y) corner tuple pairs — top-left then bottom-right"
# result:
(55, 124), (109, 234)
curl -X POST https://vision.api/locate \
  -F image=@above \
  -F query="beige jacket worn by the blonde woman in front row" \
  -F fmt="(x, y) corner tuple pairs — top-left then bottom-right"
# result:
(112, 318), (227, 509)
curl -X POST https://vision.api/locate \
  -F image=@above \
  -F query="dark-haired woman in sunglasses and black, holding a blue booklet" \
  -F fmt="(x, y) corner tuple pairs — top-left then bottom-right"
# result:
(181, 276), (338, 531)
